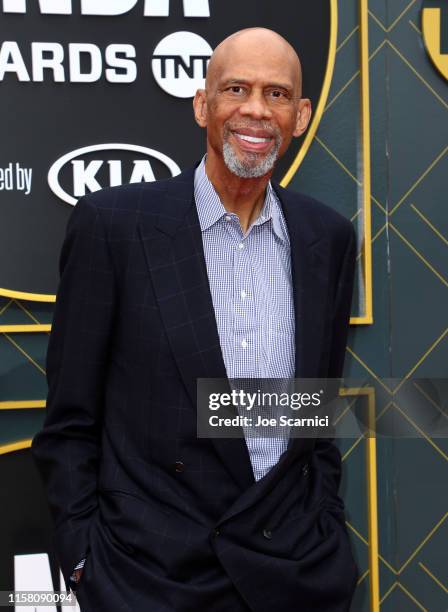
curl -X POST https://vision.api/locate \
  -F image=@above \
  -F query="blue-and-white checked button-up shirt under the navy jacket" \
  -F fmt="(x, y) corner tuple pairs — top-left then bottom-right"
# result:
(194, 157), (295, 480)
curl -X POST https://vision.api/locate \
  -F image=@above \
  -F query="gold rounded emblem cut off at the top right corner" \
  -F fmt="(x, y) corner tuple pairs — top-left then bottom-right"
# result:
(422, 0), (448, 79)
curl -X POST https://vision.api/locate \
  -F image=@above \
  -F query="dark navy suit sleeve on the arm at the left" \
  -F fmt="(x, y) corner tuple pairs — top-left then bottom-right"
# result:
(32, 198), (116, 588)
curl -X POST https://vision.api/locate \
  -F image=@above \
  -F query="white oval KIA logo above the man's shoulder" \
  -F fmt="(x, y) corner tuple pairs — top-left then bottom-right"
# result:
(48, 143), (180, 206)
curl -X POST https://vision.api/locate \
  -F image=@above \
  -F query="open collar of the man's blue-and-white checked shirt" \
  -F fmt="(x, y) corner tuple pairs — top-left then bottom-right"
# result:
(194, 155), (289, 243)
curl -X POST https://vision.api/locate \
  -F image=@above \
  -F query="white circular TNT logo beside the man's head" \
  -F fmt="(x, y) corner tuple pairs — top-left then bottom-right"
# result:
(152, 32), (213, 98)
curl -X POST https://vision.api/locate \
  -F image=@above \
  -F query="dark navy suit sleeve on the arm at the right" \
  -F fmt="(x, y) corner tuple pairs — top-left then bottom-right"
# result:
(315, 224), (356, 503)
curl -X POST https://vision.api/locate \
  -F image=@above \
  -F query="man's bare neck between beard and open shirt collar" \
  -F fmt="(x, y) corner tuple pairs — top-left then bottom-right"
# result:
(205, 154), (273, 233)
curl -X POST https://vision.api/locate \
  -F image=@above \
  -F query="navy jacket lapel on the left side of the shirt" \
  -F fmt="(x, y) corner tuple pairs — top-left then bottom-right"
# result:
(139, 169), (254, 488)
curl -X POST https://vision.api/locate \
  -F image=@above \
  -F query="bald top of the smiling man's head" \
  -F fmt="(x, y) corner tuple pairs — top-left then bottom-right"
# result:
(205, 27), (302, 96)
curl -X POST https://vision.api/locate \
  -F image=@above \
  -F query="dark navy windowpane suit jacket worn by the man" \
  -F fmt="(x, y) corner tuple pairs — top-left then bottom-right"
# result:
(32, 169), (357, 612)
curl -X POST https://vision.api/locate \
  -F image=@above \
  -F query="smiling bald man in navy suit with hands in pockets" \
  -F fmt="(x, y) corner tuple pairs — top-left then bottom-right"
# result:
(33, 28), (357, 612)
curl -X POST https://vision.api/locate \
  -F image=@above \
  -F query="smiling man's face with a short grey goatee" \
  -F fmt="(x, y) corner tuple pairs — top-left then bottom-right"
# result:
(194, 36), (310, 178)
